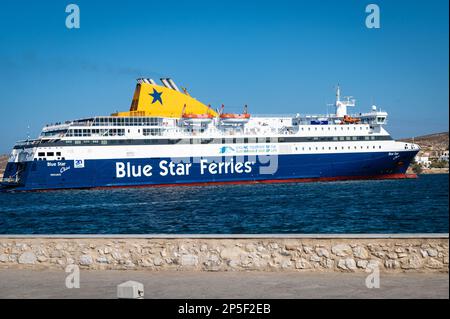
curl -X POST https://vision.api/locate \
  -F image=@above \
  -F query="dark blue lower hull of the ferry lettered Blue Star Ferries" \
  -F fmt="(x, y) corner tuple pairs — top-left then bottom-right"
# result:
(2, 150), (417, 191)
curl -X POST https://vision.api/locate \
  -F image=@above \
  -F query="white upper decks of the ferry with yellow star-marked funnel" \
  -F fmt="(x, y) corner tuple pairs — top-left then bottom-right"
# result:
(19, 79), (389, 144)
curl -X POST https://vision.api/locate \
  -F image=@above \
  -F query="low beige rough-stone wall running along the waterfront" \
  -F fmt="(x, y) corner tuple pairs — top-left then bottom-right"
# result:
(0, 235), (449, 272)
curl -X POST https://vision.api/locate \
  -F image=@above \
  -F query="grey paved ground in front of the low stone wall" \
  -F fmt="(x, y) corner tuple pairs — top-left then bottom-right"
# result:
(0, 269), (449, 299)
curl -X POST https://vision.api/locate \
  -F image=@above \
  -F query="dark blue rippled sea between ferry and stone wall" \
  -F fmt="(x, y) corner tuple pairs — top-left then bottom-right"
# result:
(0, 175), (449, 234)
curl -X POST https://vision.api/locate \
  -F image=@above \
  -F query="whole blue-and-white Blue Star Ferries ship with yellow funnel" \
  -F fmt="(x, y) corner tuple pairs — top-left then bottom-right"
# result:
(1, 78), (419, 191)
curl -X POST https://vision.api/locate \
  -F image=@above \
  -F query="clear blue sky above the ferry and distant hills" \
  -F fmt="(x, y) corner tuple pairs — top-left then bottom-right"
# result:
(0, 0), (449, 153)
